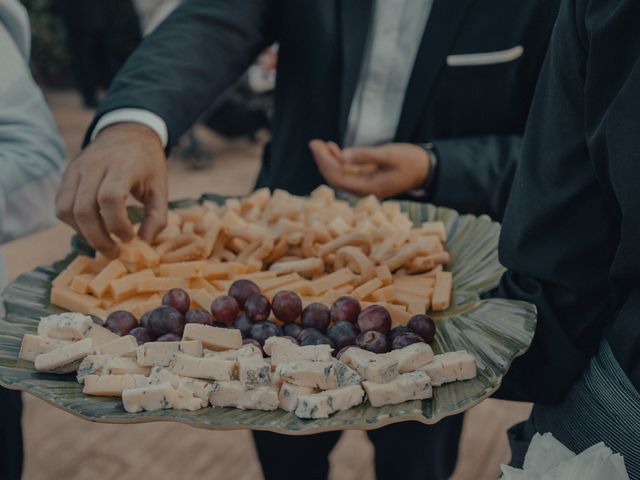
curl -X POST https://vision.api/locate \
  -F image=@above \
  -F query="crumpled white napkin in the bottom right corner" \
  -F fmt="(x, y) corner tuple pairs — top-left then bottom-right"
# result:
(501, 433), (629, 480)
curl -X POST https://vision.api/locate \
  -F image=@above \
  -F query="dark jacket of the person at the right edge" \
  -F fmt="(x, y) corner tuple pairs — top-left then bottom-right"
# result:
(498, 0), (640, 403)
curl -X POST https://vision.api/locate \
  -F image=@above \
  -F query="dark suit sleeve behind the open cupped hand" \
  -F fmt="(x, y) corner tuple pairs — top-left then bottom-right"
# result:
(429, 135), (521, 220)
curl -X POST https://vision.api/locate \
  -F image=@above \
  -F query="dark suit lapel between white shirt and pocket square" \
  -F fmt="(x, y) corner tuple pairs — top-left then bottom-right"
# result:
(396, 0), (474, 142)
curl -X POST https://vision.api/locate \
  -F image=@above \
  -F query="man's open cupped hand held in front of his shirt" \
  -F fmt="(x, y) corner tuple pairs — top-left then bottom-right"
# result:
(309, 140), (429, 198)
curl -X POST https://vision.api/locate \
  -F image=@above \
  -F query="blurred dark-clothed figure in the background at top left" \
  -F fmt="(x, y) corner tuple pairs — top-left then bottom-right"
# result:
(60, 0), (118, 108)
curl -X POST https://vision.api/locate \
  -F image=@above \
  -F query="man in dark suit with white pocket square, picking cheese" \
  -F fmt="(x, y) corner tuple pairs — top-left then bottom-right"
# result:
(57, 0), (559, 480)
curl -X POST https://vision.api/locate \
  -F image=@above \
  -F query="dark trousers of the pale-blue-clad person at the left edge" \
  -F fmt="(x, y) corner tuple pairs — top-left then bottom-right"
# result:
(0, 387), (24, 480)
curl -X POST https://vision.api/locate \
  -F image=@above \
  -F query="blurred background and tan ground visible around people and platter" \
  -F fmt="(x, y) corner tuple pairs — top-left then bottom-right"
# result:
(2, 0), (530, 480)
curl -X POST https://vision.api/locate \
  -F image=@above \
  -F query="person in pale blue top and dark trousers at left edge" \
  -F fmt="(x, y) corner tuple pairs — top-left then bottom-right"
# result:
(0, 0), (65, 480)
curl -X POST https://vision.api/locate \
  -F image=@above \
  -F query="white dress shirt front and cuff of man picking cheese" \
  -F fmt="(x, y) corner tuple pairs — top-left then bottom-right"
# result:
(91, 0), (433, 147)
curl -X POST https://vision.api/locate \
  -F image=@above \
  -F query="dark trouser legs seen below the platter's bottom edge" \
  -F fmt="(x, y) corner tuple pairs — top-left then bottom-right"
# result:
(253, 415), (464, 480)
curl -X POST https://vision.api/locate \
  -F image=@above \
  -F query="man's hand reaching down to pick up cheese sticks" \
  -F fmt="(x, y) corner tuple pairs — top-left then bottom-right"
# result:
(56, 123), (167, 258)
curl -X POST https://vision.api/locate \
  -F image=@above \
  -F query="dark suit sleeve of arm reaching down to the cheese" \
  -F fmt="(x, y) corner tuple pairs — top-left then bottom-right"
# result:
(86, 0), (276, 150)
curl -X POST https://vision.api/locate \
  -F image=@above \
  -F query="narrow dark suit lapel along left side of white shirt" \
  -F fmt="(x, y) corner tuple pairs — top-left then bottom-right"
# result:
(338, 0), (373, 141)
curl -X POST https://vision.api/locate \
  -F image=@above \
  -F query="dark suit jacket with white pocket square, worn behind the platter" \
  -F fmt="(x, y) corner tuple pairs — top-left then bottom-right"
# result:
(91, 0), (559, 217)
